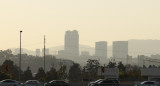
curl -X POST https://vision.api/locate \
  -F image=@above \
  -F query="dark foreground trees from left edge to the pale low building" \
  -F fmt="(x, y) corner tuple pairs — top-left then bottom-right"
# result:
(0, 59), (99, 82)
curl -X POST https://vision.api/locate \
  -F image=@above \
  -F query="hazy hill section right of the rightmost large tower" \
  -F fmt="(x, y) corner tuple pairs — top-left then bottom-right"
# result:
(128, 39), (160, 57)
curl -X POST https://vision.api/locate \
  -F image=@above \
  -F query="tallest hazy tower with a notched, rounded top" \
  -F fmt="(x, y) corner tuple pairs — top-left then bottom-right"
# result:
(64, 30), (79, 56)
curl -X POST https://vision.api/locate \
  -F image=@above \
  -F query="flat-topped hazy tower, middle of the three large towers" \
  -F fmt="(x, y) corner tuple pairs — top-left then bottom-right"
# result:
(95, 41), (107, 58)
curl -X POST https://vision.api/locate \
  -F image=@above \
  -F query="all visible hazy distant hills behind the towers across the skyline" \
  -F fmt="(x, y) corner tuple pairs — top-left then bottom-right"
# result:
(11, 39), (160, 57)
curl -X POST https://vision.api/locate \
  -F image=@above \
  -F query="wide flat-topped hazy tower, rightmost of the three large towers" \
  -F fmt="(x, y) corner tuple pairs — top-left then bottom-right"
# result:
(112, 41), (128, 64)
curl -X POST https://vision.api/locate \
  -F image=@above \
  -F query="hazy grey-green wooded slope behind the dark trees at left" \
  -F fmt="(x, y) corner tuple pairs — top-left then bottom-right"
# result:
(0, 50), (73, 74)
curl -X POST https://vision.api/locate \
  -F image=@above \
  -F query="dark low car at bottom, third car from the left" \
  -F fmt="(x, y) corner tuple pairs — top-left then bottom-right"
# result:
(44, 80), (69, 86)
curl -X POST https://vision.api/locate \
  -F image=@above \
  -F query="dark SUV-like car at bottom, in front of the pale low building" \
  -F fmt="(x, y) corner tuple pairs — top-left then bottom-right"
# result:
(91, 80), (116, 86)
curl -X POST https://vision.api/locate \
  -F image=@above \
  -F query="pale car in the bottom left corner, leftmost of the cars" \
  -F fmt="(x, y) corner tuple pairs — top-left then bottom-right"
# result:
(0, 79), (22, 86)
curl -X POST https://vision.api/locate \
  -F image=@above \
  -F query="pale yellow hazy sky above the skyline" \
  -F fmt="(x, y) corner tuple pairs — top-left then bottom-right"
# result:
(0, 0), (160, 50)
